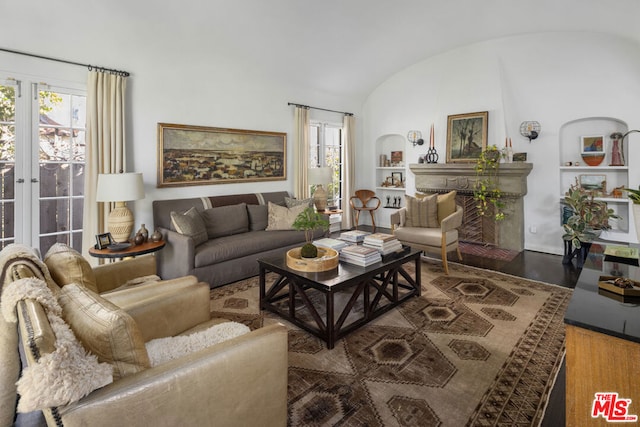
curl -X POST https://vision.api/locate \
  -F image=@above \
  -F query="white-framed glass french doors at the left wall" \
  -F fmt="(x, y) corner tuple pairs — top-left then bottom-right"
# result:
(0, 79), (86, 254)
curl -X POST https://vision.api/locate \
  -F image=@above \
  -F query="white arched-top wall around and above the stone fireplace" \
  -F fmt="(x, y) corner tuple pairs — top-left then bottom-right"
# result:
(358, 33), (640, 253)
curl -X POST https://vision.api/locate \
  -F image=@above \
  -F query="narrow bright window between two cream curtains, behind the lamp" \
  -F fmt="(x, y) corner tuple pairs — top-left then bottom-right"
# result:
(309, 121), (344, 209)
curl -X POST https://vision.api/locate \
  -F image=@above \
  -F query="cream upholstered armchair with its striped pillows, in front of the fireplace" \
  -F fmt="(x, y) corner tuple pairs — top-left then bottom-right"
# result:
(391, 191), (463, 274)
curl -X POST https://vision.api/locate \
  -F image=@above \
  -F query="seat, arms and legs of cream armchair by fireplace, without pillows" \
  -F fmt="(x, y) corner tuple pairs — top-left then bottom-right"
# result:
(391, 200), (463, 274)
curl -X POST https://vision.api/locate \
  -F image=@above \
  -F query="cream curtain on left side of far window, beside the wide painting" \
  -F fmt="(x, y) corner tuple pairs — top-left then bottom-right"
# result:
(293, 107), (311, 199)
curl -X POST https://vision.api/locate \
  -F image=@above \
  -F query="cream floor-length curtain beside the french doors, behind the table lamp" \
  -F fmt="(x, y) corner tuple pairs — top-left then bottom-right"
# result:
(82, 71), (127, 260)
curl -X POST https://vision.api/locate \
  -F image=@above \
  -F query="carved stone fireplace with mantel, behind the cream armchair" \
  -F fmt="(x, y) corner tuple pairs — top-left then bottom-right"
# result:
(409, 162), (533, 251)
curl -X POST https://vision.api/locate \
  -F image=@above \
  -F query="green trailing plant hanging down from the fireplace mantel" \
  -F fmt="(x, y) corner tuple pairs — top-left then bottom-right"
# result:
(473, 145), (505, 221)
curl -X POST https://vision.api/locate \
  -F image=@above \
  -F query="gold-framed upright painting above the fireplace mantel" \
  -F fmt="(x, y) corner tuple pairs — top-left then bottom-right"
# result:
(447, 111), (489, 163)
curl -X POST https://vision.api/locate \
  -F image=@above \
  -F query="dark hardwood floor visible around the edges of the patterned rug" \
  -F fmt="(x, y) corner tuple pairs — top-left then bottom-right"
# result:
(348, 226), (580, 427)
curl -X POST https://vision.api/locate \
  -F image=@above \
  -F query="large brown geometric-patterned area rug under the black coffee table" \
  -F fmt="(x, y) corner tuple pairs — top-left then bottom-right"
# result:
(211, 261), (571, 427)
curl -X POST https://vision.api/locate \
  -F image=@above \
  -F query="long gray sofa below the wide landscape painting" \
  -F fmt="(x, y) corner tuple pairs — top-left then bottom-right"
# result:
(153, 191), (322, 288)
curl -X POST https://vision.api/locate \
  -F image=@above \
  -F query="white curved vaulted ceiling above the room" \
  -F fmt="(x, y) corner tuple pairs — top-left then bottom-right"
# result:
(5, 0), (640, 100)
